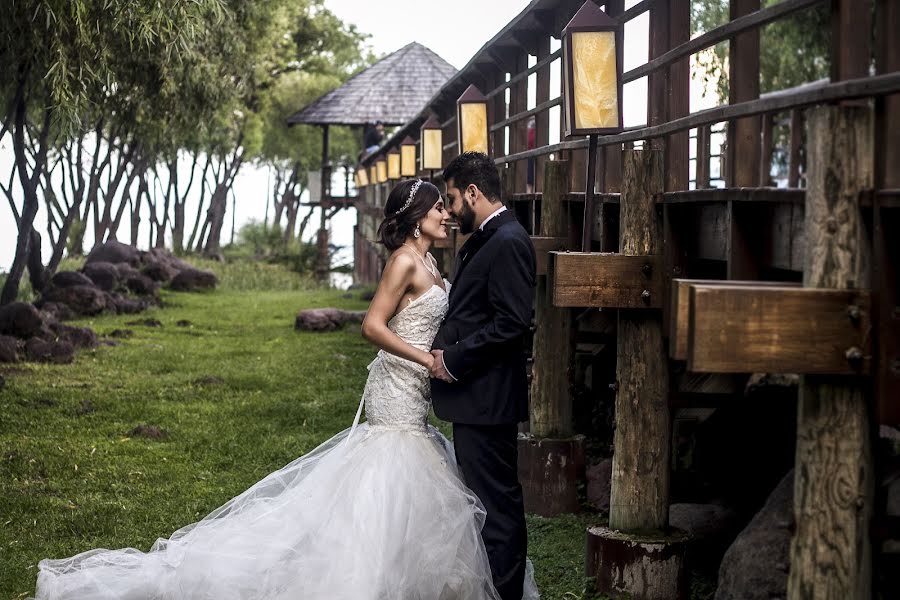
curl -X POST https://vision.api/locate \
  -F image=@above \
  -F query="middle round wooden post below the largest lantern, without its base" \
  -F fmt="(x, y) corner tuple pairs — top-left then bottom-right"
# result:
(609, 150), (669, 531)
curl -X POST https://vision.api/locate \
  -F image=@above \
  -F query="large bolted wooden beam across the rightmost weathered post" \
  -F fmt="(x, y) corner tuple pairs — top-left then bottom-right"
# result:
(686, 284), (871, 375)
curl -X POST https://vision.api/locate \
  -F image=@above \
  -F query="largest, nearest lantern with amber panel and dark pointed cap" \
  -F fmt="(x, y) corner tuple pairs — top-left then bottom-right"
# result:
(562, 0), (623, 137)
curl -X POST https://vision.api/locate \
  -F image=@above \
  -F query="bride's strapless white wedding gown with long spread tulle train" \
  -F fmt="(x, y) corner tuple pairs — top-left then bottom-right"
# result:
(36, 285), (538, 600)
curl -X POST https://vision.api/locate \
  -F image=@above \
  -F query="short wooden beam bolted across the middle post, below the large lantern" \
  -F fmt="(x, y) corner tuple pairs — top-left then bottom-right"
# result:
(548, 252), (663, 308)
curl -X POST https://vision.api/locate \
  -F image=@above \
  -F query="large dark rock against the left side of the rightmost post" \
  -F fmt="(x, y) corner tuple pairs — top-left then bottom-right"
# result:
(716, 470), (794, 600)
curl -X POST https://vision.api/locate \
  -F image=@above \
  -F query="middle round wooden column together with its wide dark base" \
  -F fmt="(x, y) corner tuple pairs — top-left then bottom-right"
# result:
(586, 150), (686, 600)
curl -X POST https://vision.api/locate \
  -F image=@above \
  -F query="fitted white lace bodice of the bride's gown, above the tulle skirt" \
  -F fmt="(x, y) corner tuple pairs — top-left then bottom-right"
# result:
(363, 285), (448, 433)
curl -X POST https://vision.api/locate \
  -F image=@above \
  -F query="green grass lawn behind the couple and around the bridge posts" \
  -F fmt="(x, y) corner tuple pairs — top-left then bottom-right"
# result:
(0, 263), (604, 600)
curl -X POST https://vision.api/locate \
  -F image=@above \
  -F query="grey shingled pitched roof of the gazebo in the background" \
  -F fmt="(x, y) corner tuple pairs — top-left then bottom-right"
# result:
(288, 42), (456, 125)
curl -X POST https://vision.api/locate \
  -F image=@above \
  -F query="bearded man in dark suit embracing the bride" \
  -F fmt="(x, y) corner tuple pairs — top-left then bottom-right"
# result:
(431, 152), (535, 600)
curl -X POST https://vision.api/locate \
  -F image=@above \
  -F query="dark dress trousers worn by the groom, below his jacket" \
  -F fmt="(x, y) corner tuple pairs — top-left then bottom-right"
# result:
(453, 423), (528, 600)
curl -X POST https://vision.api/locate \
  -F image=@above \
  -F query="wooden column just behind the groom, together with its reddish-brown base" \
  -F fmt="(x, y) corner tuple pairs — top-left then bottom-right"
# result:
(519, 161), (585, 516)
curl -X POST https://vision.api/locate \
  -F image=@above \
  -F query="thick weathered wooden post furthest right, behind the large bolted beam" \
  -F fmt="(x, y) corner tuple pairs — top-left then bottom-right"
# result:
(788, 106), (874, 600)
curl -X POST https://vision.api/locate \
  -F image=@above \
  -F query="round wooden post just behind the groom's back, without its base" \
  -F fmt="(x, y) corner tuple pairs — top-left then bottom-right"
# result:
(531, 161), (573, 437)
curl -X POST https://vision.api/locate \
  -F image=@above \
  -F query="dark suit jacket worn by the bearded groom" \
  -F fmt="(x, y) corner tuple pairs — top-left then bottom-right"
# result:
(431, 210), (535, 425)
